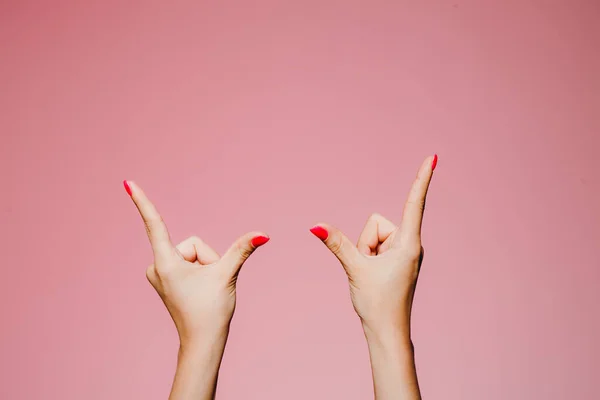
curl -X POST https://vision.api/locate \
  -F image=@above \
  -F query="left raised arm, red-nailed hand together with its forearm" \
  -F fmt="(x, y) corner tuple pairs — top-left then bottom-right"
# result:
(123, 181), (269, 399)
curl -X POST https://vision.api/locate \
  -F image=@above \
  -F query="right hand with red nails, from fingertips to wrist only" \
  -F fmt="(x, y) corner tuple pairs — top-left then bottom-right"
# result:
(311, 156), (437, 338)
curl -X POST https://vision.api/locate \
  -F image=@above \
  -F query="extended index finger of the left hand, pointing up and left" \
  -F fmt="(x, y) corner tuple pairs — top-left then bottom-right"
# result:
(123, 181), (173, 257)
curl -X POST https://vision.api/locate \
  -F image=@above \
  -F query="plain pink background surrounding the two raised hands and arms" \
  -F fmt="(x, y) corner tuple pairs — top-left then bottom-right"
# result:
(0, 0), (600, 400)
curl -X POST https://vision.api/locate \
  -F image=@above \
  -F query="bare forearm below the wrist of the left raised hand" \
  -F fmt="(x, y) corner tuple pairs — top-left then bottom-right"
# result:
(169, 330), (228, 400)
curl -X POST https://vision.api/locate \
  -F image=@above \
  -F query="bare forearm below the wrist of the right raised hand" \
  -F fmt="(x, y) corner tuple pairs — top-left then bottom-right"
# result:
(364, 322), (421, 400)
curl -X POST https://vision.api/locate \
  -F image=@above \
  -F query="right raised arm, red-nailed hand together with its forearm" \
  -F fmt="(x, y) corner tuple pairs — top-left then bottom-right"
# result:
(311, 156), (437, 400)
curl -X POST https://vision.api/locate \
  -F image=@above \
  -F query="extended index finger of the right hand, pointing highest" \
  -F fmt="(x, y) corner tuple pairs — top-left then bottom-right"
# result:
(399, 155), (437, 242)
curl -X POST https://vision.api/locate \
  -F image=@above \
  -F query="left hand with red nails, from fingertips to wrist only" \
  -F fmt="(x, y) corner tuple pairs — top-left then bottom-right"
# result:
(123, 181), (269, 345)
